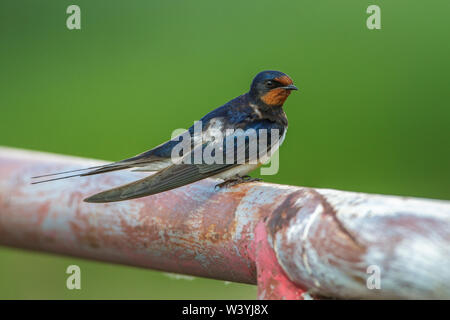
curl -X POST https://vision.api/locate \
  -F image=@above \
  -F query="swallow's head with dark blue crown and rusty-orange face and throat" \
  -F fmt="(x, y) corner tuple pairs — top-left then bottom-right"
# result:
(250, 70), (298, 107)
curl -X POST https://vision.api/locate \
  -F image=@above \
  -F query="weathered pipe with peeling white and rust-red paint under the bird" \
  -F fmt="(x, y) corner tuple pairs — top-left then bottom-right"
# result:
(0, 148), (450, 299)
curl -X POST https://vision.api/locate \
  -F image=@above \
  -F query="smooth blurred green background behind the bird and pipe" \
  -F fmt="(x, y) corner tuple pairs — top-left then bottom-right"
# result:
(0, 0), (450, 299)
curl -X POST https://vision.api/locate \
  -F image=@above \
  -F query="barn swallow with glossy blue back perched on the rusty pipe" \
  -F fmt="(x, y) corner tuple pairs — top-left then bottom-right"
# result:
(33, 70), (298, 203)
